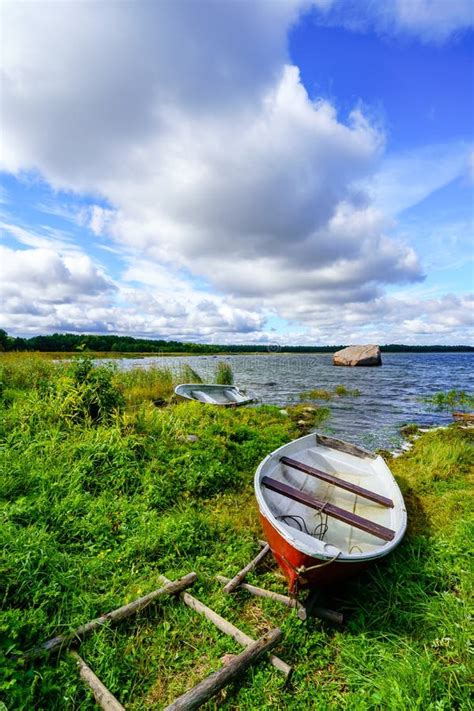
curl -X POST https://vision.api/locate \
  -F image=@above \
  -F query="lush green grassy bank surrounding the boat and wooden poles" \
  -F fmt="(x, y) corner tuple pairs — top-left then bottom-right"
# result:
(0, 357), (473, 711)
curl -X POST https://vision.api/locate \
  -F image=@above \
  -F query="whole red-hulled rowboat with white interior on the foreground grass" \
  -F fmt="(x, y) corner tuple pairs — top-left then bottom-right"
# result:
(255, 433), (407, 593)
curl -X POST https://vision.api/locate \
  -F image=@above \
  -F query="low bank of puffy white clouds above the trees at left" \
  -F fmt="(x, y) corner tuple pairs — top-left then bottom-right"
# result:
(0, 246), (265, 342)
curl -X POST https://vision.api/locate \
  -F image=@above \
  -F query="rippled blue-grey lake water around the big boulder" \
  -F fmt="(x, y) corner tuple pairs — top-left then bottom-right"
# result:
(114, 353), (474, 449)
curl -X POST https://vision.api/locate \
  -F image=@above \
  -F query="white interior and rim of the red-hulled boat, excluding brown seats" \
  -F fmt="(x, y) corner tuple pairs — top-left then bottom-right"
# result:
(255, 433), (406, 561)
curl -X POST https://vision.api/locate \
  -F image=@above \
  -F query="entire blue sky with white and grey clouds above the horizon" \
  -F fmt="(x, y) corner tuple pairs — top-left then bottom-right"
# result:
(0, 0), (474, 344)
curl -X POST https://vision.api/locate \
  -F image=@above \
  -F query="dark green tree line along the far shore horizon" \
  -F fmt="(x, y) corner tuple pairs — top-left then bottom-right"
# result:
(0, 329), (474, 355)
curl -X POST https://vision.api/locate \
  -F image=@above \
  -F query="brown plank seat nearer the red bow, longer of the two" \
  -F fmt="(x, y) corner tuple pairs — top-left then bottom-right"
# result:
(262, 476), (395, 541)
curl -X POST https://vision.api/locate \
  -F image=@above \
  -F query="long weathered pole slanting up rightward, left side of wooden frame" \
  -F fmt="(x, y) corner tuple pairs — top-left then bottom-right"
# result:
(24, 573), (197, 659)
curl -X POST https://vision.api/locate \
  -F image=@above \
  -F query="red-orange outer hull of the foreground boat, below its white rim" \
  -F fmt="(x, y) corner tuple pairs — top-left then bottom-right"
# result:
(260, 512), (372, 595)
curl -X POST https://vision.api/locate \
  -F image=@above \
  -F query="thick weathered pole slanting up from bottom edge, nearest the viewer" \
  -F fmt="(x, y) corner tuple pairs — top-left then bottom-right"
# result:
(164, 628), (281, 711)
